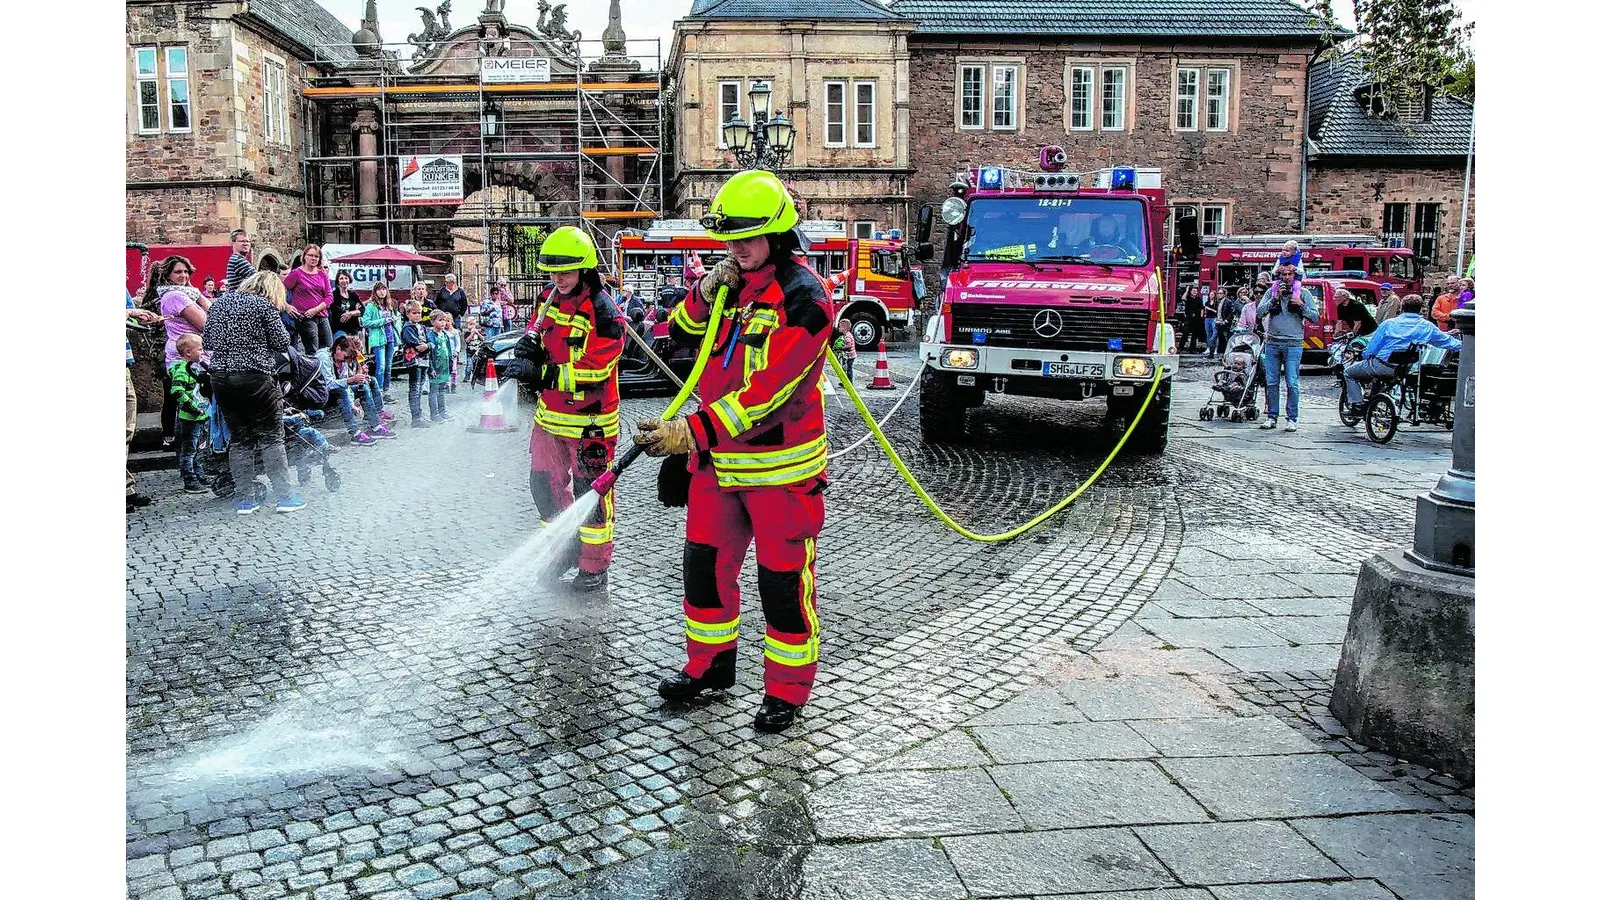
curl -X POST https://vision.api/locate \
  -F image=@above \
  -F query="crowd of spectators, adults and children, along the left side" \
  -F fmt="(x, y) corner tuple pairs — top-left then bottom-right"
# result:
(126, 231), (531, 514)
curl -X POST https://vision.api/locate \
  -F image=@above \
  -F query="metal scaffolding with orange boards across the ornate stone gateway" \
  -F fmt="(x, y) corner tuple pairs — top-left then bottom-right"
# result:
(302, 35), (667, 295)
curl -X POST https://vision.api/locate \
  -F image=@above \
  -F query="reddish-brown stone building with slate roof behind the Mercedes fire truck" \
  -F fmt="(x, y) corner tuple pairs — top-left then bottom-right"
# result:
(891, 0), (1325, 241)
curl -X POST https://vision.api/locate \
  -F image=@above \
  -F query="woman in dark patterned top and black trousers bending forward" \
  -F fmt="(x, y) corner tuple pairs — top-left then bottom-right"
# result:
(205, 271), (306, 516)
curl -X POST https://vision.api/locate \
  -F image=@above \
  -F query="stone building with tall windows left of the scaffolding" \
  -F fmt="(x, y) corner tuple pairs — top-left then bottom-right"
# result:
(125, 0), (354, 263)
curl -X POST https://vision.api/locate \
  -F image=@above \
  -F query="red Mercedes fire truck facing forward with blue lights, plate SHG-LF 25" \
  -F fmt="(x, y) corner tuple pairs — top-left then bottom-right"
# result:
(917, 147), (1178, 453)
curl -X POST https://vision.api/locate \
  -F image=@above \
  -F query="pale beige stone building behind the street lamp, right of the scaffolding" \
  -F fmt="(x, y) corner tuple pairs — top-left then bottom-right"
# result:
(667, 0), (914, 234)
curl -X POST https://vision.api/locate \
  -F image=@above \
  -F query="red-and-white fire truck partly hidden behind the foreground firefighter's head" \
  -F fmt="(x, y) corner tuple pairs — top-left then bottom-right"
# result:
(613, 219), (923, 348)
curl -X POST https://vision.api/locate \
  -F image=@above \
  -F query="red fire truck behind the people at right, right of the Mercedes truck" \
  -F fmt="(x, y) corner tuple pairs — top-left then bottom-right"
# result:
(1200, 234), (1422, 295)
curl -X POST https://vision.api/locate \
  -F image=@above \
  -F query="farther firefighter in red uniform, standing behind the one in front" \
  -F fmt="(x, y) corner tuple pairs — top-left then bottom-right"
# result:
(517, 226), (622, 591)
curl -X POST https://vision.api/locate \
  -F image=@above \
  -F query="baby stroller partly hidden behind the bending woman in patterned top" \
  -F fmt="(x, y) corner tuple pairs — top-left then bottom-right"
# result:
(202, 348), (341, 503)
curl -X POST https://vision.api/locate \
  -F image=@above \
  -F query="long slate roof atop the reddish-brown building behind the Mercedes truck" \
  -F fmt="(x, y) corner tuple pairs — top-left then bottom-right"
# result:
(893, 0), (1349, 38)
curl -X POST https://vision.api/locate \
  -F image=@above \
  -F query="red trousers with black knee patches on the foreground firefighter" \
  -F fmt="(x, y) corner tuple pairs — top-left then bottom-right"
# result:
(683, 468), (822, 705)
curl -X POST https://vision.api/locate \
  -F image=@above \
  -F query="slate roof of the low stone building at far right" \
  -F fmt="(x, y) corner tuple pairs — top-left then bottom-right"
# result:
(1310, 53), (1472, 157)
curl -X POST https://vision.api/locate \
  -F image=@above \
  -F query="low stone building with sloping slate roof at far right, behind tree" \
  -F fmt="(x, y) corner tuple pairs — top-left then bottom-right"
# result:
(1307, 56), (1474, 272)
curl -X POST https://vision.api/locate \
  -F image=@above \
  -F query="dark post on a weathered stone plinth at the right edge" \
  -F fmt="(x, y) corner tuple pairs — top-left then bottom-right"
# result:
(1330, 307), (1477, 783)
